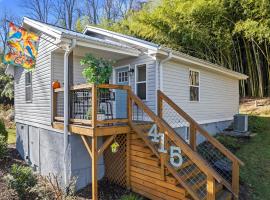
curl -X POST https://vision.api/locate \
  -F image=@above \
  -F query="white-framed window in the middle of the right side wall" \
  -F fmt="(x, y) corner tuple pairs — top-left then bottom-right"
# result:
(189, 70), (200, 101)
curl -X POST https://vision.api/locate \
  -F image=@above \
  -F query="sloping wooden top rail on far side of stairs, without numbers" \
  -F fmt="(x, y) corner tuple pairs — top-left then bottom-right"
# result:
(158, 90), (244, 166)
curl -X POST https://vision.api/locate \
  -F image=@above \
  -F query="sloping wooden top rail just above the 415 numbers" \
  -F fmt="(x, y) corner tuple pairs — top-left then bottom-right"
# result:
(130, 91), (224, 183)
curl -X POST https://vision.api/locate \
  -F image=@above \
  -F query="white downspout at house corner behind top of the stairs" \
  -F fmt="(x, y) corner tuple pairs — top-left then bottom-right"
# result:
(156, 51), (172, 114)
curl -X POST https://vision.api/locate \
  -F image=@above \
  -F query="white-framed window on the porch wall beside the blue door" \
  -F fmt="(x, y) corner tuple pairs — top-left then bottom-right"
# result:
(136, 64), (146, 100)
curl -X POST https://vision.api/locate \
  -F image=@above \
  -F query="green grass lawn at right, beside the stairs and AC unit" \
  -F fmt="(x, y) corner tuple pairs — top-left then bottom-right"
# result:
(218, 116), (270, 200)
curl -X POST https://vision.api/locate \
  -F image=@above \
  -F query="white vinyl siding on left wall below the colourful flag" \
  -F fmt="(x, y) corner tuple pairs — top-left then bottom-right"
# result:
(14, 34), (56, 126)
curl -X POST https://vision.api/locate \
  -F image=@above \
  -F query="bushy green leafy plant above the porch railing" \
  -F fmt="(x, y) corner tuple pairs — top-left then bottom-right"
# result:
(80, 54), (113, 84)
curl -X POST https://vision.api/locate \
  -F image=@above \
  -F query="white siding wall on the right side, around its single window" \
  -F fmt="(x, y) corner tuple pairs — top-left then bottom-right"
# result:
(161, 62), (239, 124)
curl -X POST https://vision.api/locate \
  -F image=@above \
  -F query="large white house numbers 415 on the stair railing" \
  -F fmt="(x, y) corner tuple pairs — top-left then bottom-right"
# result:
(148, 124), (183, 168)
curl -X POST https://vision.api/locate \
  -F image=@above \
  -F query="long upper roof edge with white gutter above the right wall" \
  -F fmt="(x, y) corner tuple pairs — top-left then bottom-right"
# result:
(84, 26), (248, 80)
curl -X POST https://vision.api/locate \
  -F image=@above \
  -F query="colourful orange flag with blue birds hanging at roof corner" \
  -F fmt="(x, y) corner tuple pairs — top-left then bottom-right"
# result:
(4, 22), (39, 70)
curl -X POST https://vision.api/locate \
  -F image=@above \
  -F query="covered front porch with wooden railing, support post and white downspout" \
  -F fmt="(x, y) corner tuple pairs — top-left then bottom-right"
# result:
(51, 42), (143, 199)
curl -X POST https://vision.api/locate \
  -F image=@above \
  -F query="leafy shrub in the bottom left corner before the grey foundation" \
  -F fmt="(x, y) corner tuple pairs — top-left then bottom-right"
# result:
(5, 164), (37, 199)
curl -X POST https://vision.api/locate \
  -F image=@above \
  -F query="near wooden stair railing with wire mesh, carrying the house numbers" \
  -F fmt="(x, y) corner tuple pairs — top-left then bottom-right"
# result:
(128, 89), (226, 200)
